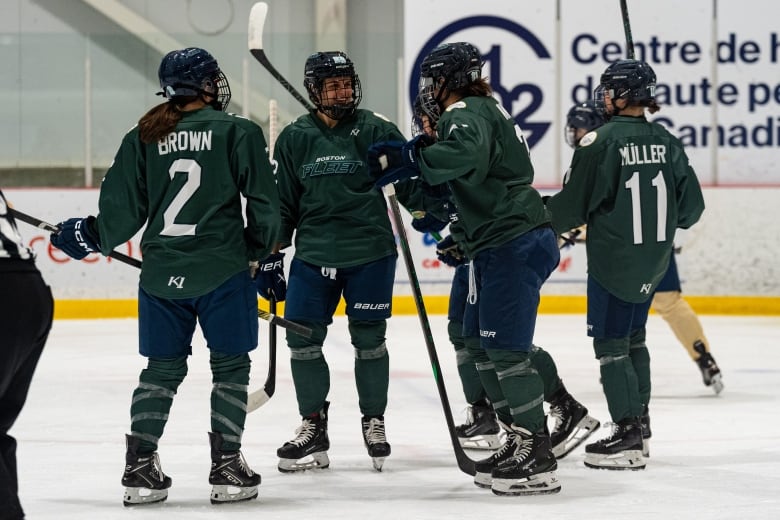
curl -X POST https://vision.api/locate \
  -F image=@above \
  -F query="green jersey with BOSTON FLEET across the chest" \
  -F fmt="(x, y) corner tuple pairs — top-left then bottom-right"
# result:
(274, 109), (436, 267)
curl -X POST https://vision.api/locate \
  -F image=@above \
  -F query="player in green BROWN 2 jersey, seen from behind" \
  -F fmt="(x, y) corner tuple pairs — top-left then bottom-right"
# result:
(51, 48), (283, 505)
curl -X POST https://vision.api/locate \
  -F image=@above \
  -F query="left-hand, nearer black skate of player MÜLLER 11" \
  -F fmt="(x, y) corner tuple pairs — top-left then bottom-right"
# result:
(585, 417), (645, 470)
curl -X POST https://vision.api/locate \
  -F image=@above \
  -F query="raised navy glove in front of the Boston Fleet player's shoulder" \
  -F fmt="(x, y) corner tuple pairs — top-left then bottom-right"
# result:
(367, 134), (433, 188)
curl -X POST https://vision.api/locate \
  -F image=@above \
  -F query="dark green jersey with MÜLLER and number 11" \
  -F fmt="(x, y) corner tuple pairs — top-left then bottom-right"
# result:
(547, 116), (704, 303)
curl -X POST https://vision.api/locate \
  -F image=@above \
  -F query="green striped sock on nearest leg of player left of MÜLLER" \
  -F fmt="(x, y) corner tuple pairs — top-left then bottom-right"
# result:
(487, 349), (545, 433)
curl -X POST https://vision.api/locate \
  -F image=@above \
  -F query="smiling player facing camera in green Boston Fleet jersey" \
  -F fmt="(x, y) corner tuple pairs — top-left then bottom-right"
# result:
(274, 51), (444, 472)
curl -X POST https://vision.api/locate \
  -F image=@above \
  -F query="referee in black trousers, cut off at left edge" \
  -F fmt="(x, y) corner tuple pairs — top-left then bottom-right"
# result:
(0, 191), (54, 520)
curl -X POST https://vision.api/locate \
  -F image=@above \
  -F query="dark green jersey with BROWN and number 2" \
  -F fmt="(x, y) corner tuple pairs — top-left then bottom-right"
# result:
(97, 107), (279, 298)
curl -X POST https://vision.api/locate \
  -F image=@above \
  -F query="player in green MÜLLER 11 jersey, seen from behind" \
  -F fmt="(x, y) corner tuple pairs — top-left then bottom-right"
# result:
(547, 60), (704, 469)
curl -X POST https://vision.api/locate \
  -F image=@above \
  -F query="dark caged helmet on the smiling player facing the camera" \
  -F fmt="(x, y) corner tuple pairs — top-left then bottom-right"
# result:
(303, 51), (363, 120)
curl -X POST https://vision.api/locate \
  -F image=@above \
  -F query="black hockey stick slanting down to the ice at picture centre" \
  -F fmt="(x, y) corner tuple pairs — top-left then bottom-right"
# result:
(382, 184), (476, 475)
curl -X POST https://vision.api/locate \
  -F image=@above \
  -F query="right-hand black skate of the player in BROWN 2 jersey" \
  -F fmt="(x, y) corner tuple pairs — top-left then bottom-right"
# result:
(209, 432), (260, 504)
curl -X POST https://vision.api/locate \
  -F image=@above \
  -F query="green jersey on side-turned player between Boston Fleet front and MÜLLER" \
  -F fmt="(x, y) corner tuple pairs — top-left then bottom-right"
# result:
(420, 97), (549, 258)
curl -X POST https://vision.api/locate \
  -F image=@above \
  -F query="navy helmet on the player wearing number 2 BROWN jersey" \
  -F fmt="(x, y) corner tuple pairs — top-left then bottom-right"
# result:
(157, 47), (230, 110)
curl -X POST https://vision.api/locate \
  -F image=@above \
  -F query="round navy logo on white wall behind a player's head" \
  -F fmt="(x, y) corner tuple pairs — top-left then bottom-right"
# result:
(409, 15), (552, 148)
